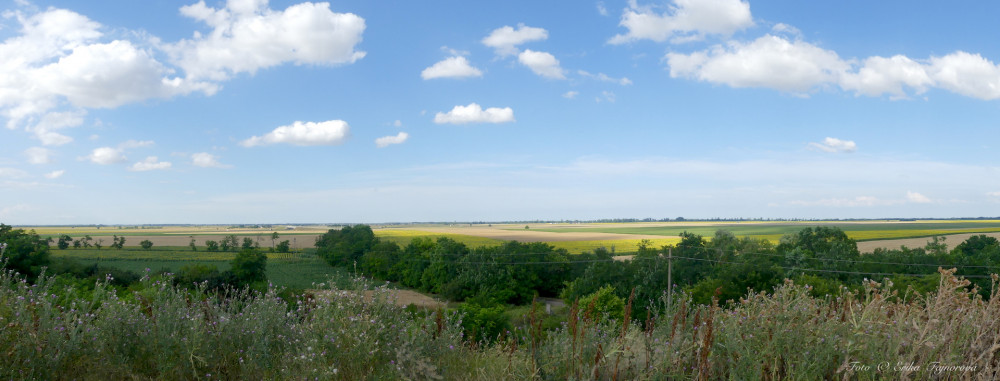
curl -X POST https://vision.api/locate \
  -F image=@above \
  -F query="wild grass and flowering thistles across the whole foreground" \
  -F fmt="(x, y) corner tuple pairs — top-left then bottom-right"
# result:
(0, 262), (1000, 380)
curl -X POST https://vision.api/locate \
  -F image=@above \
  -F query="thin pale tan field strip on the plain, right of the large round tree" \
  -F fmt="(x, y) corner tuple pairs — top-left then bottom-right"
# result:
(381, 224), (677, 242)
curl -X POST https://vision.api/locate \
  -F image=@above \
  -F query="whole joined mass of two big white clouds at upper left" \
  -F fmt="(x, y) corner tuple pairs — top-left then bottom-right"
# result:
(0, 0), (365, 146)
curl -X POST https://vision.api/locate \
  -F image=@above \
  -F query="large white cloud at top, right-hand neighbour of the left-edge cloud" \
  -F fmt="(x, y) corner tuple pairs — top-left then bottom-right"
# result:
(166, 0), (365, 81)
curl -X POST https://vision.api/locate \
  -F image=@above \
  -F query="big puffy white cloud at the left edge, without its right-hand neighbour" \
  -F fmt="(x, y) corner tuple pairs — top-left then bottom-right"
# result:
(0, 7), (212, 145)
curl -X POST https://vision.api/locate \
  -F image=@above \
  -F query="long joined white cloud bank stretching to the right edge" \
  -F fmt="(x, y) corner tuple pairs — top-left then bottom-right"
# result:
(665, 30), (1000, 100)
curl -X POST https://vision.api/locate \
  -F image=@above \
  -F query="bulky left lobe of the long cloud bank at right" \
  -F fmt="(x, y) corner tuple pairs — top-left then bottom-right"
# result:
(666, 35), (849, 94)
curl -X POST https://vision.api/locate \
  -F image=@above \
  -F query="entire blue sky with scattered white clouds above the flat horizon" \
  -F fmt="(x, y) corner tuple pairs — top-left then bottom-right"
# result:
(0, 0), (1000, 224)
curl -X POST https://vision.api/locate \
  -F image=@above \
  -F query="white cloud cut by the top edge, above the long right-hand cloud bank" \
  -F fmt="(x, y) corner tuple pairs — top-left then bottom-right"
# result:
(608, 0), (753, 44)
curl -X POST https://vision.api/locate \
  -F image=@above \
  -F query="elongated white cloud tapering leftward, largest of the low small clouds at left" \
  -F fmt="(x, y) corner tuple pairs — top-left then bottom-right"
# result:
(240, 120), (350, 147)
